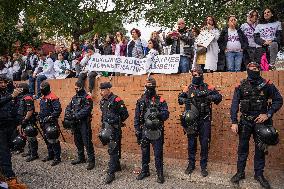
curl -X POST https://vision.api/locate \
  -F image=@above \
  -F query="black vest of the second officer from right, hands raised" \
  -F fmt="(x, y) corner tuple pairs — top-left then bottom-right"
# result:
(187, 83), (211, 115)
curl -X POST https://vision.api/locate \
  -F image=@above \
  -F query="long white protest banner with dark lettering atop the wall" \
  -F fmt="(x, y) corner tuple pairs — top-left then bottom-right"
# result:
(88, 55), (180, 75)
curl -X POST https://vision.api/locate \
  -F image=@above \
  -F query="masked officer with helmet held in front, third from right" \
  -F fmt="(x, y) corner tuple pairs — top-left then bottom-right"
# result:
(134, 76), (169, 183)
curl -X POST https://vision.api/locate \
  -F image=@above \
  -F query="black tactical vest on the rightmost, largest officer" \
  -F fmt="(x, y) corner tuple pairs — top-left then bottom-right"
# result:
(240, 79), (268, 114)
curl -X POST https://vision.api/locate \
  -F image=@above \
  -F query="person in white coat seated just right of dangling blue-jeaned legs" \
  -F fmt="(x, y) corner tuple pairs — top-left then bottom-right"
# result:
(54, 53), (71, 78)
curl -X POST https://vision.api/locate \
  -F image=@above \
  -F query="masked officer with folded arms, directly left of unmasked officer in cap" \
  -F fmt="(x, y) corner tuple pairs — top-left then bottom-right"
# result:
(65, 81), (95, 170)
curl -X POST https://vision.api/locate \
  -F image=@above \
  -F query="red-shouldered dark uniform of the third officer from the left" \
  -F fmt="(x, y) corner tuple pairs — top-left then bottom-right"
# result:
(39, 92), (62, 162)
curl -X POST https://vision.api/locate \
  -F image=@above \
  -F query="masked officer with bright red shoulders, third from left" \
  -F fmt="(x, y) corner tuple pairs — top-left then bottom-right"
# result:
(38, 81), (62, 166)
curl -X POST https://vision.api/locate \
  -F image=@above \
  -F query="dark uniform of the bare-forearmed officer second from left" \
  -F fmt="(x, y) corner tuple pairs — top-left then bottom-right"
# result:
(18, 94), (38, 161)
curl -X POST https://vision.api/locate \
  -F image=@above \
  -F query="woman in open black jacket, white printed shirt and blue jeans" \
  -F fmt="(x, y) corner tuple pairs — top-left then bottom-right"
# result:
(218, 15), (248, 72)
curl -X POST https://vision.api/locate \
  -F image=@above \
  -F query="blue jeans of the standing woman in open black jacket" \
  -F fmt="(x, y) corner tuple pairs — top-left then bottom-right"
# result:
(226, 52), (243, 72)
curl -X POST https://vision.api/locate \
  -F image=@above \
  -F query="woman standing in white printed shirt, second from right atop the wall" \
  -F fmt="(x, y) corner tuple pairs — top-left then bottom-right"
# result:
(240, 10), (261, 67)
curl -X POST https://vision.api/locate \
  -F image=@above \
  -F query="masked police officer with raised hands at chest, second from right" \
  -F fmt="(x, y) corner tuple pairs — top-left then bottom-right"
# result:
(178, 68), (222, 177)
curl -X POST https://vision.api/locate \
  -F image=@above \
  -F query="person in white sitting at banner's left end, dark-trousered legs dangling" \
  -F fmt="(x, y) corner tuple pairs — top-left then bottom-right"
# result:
(78, 45), (101, 95)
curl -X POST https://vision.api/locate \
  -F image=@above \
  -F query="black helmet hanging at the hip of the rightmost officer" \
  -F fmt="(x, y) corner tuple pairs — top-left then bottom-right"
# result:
(255, 124), (279, 145)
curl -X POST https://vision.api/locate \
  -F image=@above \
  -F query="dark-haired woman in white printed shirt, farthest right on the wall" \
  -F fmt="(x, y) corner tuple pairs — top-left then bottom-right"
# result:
(254, 8), (282, 70)
